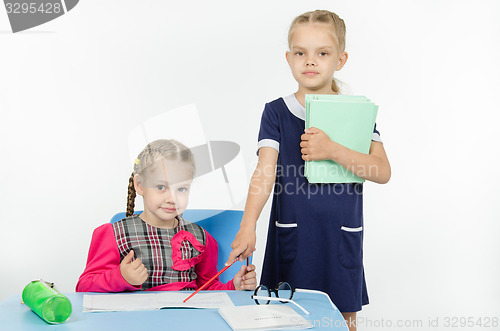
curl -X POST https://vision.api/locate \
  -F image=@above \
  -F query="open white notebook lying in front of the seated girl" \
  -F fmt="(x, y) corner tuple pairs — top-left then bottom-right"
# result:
(83, 291), (234, 312)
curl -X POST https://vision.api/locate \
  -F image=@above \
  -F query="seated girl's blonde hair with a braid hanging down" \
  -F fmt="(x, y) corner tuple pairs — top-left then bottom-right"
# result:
(126, 139), (195, 217)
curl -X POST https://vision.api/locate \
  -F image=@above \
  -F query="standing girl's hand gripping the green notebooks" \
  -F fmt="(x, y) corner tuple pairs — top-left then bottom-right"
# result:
(300, 127), (341, 161)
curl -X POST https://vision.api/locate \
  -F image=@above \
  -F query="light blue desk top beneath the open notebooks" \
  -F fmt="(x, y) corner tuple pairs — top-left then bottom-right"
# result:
(0, 291), (347, 331)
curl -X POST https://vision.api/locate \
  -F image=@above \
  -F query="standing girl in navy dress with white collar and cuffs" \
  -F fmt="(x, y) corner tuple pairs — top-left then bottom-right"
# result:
(228, 10), (391, 330)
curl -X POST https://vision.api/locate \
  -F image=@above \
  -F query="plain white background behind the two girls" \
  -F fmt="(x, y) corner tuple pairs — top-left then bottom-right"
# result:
(0, 0), (500, 330)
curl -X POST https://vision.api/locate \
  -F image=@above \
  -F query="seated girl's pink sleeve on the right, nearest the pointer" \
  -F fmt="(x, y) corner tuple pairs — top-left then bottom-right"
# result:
(196, 231), (234, 290)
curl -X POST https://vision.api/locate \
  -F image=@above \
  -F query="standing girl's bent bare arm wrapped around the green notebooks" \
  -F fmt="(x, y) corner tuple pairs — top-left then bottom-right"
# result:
(300, 127), (391, 184)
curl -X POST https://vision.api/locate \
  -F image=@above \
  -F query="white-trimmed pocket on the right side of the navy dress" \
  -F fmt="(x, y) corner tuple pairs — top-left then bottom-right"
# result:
(338, 226), (363, 268)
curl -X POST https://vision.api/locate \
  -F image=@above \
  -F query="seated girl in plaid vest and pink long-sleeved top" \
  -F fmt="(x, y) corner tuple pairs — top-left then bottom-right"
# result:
(76, 140), (256, 292)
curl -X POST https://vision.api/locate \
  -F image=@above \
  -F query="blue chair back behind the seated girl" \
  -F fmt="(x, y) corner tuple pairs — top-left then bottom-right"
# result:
(110, 209), (251, 283)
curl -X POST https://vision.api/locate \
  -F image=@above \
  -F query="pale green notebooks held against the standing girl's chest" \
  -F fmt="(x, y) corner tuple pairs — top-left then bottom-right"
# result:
(305, 94), (378, 183)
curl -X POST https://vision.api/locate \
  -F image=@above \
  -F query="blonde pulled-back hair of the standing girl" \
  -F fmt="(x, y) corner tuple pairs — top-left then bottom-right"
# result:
(288, 9), (346, 92)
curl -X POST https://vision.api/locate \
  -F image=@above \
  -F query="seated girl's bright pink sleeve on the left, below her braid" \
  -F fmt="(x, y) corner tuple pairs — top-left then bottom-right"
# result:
(76, 223), (141, 292)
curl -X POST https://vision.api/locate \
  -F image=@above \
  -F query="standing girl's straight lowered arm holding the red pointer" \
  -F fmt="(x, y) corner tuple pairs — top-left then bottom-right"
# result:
(226, 147), (278, 265)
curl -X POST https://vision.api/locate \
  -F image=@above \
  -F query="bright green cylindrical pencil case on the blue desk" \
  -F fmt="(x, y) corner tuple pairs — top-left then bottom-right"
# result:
(22, 280), (71, 324)
